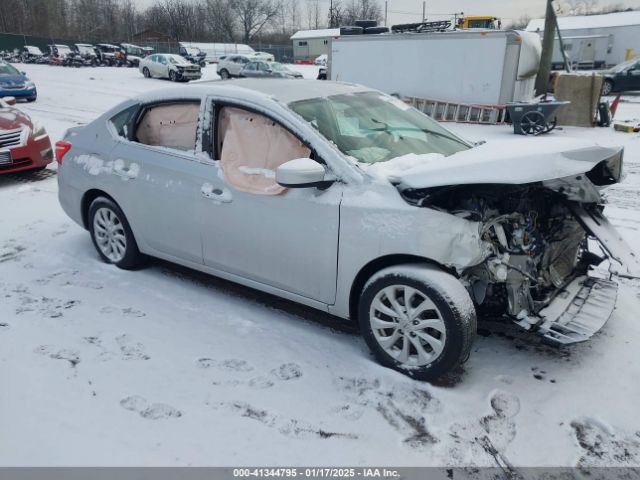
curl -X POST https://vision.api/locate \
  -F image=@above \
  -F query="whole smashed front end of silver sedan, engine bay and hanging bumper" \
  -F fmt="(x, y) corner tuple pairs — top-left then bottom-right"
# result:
(397, 149), (640, 344)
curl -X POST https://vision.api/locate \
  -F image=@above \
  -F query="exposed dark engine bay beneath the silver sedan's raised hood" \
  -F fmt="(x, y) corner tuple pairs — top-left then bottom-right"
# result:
(402, 184), (604, 338)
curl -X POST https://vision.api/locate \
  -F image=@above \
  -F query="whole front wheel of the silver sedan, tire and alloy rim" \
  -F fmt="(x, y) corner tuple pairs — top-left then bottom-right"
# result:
(358, 265), (476, 381)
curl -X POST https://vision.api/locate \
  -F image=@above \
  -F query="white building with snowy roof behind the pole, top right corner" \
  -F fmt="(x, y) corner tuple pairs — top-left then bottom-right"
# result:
(527, 11), (640, 68)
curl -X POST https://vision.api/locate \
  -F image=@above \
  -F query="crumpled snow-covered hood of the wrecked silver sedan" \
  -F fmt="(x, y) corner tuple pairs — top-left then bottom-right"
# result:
(388, 136), (622, 188)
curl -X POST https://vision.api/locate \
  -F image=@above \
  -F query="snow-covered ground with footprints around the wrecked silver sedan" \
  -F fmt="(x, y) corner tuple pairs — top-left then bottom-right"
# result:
(0, 65), (640, 466)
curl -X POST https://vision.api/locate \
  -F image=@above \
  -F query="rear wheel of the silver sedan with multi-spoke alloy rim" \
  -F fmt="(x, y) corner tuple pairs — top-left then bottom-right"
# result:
(88, 197), (144, 269)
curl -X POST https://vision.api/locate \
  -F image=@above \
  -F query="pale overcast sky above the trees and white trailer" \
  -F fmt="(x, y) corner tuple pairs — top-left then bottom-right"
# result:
(134, 0), (640, 25)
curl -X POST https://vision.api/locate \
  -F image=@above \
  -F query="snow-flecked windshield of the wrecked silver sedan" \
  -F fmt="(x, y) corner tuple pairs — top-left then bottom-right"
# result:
(289, 92), (471, 164)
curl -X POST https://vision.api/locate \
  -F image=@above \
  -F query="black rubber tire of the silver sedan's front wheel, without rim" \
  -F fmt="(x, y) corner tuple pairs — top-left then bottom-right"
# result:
(358, 265), (477, 381)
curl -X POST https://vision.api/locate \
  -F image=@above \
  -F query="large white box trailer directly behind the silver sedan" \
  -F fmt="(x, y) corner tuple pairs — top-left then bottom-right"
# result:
(328, 30), (541, 105)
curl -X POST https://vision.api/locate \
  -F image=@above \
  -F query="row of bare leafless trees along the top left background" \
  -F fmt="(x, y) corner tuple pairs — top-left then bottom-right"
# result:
(0, 0), (382, 43)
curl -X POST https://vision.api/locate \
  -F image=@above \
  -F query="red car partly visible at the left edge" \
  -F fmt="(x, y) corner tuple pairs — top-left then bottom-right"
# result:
(0, 97), (53, 174)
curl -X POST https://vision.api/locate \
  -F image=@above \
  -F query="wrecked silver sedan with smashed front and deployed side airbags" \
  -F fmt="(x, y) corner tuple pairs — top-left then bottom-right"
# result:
(56, 79), (640, 380)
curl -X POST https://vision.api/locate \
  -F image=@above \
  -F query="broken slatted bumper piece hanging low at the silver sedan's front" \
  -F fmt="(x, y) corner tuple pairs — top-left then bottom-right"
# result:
(537, 276), (618, 345)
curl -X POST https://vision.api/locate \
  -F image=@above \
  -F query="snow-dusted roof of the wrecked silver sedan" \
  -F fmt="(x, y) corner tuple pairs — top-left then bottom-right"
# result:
(139, 78), (375, 104)
